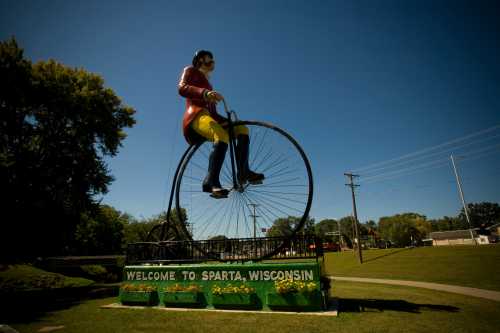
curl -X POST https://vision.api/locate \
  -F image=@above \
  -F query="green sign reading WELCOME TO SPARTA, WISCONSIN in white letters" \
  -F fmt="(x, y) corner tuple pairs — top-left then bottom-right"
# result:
(123, 261), (322, 310)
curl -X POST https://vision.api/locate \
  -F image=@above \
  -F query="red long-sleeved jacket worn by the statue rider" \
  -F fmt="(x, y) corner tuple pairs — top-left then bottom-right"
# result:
(179, 66), (224, 144)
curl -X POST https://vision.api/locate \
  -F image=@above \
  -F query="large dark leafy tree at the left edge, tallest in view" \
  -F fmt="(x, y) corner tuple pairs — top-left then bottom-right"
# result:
(0, 39), (135, 259)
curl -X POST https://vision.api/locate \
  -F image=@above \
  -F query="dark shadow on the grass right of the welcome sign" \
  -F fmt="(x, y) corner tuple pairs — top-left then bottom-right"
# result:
(339, 298), (460, 313)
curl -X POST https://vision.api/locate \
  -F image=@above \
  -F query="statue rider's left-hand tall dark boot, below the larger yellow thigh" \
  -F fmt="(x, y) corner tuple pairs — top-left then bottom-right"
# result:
(203, 141), (229, 199)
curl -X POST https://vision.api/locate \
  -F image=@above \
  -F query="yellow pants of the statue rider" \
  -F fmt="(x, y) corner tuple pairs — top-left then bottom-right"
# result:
(191, 111), (248, 143)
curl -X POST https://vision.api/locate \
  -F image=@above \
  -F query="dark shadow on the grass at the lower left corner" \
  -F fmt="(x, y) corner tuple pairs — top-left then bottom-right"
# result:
(0, 286), (118, 324)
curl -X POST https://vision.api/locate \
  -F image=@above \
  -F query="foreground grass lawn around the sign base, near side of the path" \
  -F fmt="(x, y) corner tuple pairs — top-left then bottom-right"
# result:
(7, 282), (500, 333)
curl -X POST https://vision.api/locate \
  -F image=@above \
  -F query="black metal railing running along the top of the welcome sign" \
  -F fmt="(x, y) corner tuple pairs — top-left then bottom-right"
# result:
(126, 235), (323, 265)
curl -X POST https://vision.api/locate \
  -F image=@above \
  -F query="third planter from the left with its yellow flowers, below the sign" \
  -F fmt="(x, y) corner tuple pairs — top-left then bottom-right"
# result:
(212, 284), (261, 309)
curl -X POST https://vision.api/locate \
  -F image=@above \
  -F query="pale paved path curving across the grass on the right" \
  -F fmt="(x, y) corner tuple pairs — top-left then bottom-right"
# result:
(329, 276), (500, 302)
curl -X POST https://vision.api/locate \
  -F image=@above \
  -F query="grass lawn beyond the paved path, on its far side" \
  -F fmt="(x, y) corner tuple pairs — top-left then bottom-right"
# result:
(324, 244), (500, 290)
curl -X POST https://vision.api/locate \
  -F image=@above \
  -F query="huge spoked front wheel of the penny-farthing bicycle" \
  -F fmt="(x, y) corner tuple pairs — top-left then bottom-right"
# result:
(175, 121), (313, 259)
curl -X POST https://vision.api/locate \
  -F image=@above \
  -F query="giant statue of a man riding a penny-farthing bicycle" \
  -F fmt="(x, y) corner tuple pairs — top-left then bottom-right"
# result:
(149, 50), (313, 260)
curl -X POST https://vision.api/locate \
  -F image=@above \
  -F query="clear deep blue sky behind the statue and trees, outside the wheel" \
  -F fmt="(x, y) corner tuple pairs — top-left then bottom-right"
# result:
(0, 0), (500, 221)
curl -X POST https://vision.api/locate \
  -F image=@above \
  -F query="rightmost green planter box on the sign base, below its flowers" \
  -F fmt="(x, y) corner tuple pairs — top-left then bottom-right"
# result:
(267, 291), (323, 311)
